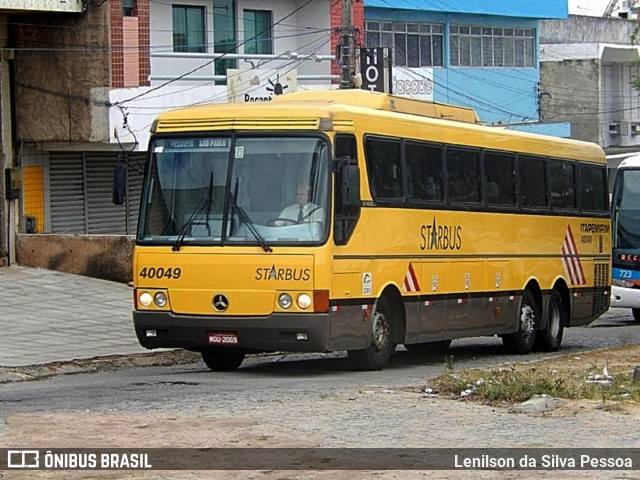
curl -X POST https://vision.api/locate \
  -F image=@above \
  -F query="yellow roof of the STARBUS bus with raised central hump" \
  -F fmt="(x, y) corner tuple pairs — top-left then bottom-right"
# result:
(152, 89), (606, 163)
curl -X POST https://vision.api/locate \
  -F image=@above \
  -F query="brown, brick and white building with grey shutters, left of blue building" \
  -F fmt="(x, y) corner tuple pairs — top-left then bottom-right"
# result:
(4, 0), (344, 276)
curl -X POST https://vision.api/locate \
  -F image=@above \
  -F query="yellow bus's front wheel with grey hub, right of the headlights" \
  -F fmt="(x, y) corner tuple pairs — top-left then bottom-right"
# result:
(347, 298), (396, 370)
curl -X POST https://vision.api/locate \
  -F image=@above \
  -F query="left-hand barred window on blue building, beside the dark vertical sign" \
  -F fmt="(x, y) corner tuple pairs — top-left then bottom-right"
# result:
(365, 21), (444, 67)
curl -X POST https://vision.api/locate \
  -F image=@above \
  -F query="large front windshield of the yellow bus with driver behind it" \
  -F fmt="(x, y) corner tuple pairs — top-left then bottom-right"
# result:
(138, 135), (330, 251)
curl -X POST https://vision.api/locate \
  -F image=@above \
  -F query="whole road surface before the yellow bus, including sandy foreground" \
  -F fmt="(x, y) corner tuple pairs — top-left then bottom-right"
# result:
(0, 310), (640, 480)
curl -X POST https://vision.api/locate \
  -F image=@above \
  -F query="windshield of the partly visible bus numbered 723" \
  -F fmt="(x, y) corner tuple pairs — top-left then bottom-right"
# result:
(612, 169), (640, 249)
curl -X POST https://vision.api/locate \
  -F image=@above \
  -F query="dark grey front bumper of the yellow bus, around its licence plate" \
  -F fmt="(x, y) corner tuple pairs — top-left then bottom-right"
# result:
(133, 310), (331, 352)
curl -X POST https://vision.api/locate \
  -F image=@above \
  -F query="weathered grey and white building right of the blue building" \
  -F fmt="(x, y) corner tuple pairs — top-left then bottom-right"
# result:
(540, 15), (640, 186)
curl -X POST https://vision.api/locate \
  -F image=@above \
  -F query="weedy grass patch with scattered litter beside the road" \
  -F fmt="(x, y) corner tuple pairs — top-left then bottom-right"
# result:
(428, 365), (640, 404)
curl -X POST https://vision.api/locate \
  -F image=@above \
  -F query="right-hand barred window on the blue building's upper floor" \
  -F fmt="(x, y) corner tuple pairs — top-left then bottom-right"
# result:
(449, 25), (536, 67)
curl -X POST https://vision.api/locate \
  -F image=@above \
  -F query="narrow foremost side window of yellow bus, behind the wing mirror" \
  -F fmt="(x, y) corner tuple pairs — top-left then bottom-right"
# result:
(333, 135), (360, 245)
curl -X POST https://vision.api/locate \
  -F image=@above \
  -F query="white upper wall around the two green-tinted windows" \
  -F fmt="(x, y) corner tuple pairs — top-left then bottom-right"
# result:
(114, 0), (333, 151)
